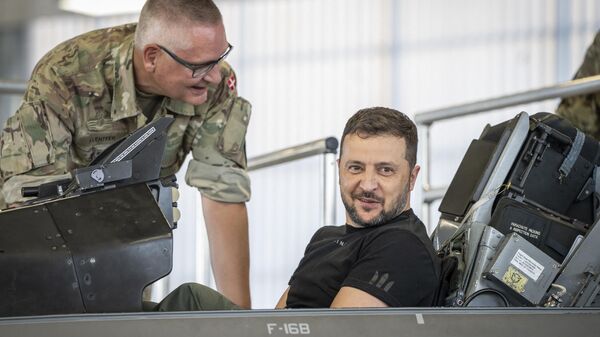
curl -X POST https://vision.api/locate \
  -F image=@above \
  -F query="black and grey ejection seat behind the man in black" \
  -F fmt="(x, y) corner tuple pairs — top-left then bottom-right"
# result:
(433, 112), (600, 307)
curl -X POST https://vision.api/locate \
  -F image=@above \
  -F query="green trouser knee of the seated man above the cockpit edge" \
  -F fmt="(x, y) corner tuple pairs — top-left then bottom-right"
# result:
(144, 283), (242, 311)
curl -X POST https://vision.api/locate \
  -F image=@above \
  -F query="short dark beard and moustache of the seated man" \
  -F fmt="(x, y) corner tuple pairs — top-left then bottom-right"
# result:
(342, 184), (408, 227)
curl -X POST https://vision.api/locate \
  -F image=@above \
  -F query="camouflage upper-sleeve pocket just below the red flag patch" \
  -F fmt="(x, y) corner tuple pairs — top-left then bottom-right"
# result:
(217, 97), (252, 167)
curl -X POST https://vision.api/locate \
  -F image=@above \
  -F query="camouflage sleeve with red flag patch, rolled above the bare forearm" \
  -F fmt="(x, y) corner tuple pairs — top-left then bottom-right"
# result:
(185, 66), (251, 202)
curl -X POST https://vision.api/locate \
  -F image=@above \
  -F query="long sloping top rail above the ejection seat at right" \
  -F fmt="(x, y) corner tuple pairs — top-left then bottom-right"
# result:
(415, 75), (600, 125)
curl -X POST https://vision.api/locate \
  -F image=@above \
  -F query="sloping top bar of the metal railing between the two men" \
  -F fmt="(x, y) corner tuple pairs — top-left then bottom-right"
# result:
(248, 137), (338, 171)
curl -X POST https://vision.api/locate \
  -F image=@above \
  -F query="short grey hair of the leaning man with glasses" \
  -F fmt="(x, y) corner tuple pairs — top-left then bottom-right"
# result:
(135, 0), (223, 49)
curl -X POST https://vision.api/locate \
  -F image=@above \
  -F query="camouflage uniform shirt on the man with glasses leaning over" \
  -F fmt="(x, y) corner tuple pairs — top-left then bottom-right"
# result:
(0, 24), (251, 204)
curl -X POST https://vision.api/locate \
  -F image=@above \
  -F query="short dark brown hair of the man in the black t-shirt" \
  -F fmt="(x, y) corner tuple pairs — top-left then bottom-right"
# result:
(340, 107), (418, 169)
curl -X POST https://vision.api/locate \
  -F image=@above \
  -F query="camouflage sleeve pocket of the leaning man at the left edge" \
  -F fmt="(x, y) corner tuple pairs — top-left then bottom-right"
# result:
(0, 102), (54, 178)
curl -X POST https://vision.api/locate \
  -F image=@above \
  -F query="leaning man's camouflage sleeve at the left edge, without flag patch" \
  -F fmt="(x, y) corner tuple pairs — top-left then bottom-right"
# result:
(0, 59), (71, 204)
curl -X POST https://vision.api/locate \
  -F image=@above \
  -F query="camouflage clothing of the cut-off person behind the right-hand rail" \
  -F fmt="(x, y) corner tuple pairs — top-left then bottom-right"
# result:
(556, 31), (600, 140)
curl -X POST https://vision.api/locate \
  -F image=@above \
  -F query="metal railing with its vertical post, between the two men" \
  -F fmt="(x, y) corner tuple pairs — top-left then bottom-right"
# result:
(248, 137), (338, 225)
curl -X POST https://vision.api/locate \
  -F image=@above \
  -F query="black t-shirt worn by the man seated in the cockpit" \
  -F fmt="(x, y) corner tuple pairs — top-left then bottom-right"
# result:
(286, 209), (440, 308)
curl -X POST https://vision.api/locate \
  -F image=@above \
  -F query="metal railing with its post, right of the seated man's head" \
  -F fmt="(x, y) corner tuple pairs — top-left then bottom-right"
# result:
(415, 75), (600, 225)
